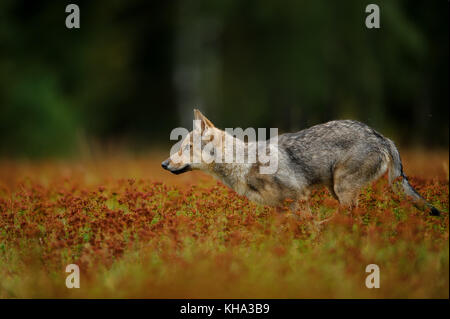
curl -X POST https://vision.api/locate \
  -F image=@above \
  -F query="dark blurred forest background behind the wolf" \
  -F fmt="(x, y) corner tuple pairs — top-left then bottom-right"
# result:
(0, 0), (449, 157)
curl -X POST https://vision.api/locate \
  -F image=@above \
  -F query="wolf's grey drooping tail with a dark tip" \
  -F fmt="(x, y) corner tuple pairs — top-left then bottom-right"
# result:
(386, 138), (441, 216)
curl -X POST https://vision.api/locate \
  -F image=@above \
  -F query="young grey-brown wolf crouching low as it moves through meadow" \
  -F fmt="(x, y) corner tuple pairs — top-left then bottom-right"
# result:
(161, 109), (440, 216)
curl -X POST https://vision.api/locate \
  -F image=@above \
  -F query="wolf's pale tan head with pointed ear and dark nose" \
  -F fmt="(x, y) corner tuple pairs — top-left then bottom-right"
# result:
(161, 109), (224, 174)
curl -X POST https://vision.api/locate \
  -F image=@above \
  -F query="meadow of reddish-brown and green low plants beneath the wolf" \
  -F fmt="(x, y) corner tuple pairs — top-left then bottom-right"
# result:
(0, 150), (449, 298)
